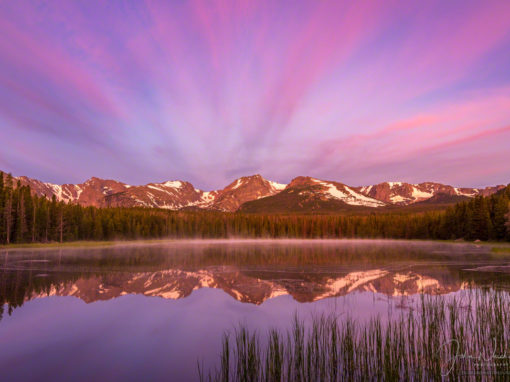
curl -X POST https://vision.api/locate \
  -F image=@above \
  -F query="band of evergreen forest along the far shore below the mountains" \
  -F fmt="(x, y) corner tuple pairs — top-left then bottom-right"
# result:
(0, 173), (510, 244)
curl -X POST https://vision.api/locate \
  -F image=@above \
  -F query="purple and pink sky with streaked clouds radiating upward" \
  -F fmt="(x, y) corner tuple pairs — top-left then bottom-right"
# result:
(0, 0), (510, 190)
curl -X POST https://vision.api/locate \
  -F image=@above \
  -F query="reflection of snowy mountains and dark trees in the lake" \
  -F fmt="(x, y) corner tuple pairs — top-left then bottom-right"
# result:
(0, 242), (510, 309)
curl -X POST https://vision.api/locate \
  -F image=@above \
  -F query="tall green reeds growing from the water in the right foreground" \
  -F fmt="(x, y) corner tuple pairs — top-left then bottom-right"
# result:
(200, 289), (510, 381)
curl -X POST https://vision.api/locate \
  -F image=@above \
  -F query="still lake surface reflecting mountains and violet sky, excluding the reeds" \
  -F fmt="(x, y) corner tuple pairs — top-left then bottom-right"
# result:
(0, 240), (510, 381)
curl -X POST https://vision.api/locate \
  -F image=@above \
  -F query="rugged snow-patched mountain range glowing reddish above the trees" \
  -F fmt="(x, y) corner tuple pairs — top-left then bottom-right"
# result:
(7, 174), (505, 212)
